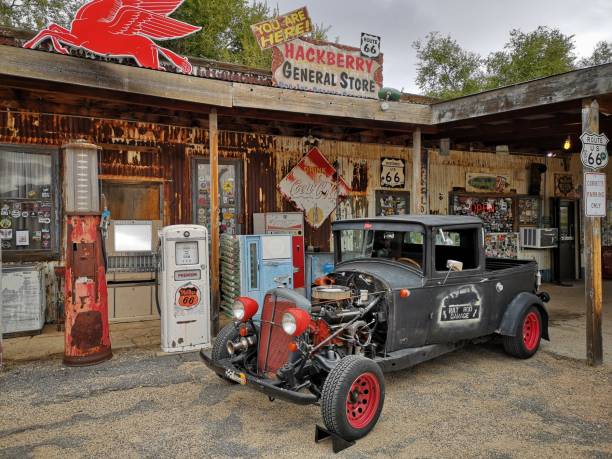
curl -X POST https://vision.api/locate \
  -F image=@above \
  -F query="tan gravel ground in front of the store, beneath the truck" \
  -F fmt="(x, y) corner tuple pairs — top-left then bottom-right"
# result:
(0, 344), (612, 458)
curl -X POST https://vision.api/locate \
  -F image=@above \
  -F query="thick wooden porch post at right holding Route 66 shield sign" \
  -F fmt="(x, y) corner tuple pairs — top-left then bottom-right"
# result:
(582, 99), (603, 366)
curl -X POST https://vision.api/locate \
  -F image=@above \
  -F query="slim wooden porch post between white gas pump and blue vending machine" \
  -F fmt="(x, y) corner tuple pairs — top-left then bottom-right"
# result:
(208, 108), (220, 336)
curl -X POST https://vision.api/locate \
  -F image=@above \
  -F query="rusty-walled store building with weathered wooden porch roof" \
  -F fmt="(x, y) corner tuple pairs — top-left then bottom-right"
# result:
(0, 30), (612, 330)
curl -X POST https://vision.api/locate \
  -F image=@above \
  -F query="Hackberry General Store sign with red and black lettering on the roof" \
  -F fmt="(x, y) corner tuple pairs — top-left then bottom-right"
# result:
(272, 38), (383, 99)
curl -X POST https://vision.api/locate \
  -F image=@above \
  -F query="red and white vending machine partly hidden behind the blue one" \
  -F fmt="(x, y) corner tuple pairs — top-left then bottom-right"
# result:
(253, 212), (306, 294)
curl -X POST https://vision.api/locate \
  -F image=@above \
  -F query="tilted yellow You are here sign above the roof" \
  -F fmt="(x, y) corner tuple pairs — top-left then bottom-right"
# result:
(251, 6), (312, 49)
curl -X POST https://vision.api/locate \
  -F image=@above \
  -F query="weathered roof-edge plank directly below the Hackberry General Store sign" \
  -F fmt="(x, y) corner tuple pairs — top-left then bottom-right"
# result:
(233, 83), (431, 125)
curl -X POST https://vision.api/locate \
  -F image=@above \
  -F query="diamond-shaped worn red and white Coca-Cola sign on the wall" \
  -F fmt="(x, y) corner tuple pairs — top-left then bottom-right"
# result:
(278, 147), (350, 228)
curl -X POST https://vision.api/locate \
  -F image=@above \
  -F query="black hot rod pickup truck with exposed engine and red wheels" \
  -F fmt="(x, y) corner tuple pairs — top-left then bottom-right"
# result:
(201, 215), (549, 440)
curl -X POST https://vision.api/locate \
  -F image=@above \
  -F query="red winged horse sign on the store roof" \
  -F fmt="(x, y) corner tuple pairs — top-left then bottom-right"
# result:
(23, 0), (201, 74)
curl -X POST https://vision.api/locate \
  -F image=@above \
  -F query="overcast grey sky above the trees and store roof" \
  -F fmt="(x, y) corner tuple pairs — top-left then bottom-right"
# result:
(268, 0), (612, 93)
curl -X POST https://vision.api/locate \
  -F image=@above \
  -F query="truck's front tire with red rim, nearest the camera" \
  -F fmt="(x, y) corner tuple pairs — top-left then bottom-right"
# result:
(321, 355), (385, 440)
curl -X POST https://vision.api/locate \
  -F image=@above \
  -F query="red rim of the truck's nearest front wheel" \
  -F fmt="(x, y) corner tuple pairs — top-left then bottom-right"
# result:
(346, 373), (380, 429)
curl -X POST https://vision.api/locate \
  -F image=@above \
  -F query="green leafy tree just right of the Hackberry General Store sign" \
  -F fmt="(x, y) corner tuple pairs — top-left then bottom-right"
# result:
(412, 32), (483, 99)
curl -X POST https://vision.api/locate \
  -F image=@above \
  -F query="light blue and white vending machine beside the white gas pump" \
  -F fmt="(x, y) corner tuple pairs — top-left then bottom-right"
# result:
(220, 234), (293, 319)
